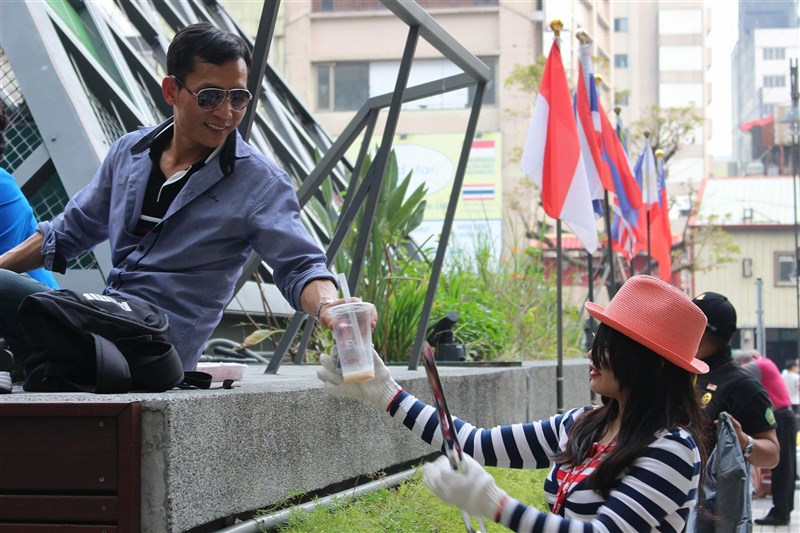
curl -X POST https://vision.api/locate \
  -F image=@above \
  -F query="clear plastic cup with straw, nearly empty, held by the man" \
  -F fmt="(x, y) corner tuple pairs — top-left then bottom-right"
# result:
(328, 302), (375, 383)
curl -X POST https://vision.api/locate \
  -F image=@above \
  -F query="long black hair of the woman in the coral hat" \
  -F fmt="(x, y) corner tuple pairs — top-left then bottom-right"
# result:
(557, 324), (708, 498)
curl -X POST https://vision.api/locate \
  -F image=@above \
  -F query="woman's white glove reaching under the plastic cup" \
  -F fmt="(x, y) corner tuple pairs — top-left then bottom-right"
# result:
(317, 346), (402, 410)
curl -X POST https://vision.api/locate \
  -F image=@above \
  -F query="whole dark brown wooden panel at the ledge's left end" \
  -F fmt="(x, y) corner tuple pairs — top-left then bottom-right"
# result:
(0, 402), (141, 533)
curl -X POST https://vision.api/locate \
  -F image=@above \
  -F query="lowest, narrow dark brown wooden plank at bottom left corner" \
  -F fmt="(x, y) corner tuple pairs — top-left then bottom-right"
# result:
(0, 494), (118, 524)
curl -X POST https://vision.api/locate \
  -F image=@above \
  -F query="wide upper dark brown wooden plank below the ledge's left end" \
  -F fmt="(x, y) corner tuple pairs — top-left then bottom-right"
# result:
(0, 416), (117, 493)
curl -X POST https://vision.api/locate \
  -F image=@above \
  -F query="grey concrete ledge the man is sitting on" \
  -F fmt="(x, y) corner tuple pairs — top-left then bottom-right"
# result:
(3, 359), (590, 533)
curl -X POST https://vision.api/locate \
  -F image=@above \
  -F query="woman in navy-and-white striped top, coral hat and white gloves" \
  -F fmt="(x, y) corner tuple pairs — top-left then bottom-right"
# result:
(318, 276), (708, 532)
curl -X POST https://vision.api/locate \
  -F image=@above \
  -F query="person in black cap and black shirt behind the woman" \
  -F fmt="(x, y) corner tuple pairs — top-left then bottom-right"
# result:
(692, 292), (788, 523)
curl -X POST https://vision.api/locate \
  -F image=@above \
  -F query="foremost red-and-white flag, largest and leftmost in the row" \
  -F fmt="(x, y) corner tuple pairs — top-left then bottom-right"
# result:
(522, 39), (597, 253)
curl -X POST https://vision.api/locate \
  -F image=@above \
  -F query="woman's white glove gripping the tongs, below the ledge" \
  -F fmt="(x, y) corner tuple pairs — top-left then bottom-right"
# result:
(422, 454), (507, 520)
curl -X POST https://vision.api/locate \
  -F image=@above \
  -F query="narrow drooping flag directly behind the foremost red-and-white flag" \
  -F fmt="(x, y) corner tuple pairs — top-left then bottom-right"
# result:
(573, 44), (613, 216)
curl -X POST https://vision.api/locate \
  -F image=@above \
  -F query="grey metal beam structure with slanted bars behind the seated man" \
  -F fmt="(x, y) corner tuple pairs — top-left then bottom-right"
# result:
(0, 0), (490, 373)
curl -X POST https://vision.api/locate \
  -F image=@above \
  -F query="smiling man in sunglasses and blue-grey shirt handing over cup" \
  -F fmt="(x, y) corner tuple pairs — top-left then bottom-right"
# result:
(0, 23), (362, 377)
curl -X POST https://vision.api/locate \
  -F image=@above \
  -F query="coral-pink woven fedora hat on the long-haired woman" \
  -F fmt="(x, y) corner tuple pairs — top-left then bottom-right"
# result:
(584, 276), (708, 374)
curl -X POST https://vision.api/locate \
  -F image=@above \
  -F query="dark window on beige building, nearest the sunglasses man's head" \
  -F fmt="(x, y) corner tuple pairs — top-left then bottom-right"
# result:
(317, 62), (369, 111)
